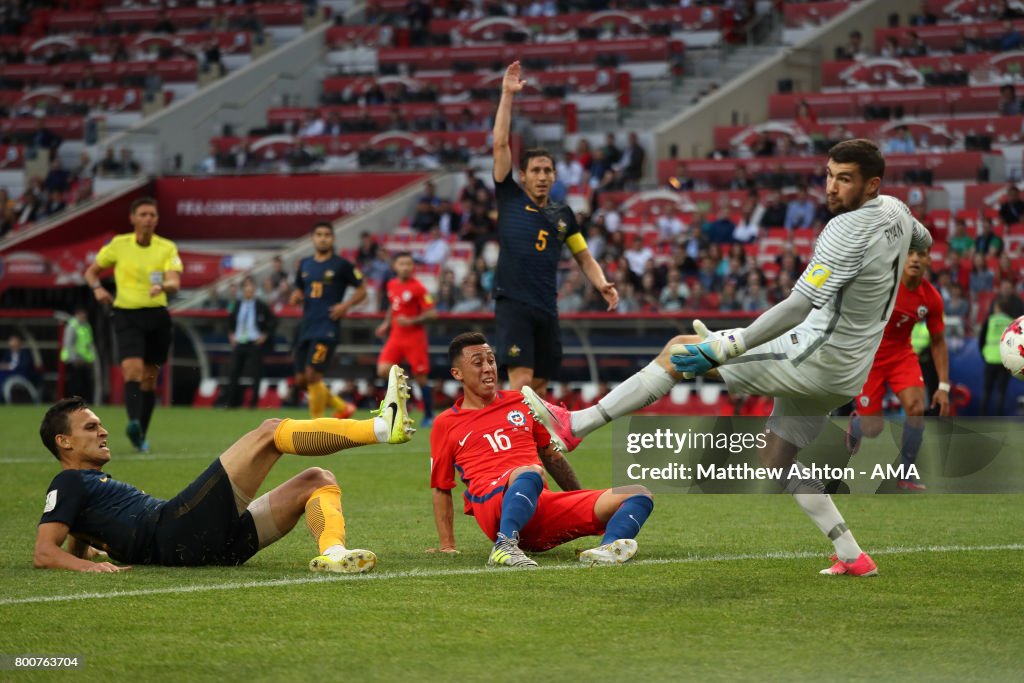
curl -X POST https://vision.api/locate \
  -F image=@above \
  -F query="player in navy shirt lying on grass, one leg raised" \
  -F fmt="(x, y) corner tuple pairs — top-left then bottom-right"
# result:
(35, 366), (415, 573)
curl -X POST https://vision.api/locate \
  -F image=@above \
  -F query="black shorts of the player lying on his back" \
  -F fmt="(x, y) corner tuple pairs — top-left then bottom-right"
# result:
(156, 458), (259, 566)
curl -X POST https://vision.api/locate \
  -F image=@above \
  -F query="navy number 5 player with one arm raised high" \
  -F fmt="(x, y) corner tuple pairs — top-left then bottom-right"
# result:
(494, 61), (618, 395)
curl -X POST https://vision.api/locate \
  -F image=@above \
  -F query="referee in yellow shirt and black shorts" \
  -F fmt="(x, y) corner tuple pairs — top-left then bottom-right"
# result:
(85, 198), (182, 453)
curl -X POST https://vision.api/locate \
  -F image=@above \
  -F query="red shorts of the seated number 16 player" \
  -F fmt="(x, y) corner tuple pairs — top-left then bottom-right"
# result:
(470, 479), (604, 551)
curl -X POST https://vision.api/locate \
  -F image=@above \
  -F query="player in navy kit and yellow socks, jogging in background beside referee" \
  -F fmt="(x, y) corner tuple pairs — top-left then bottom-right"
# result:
(291, 223), (367, 419)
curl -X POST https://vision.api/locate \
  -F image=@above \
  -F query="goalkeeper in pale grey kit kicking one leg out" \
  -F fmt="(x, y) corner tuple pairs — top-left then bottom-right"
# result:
(523, 140), (932, 577)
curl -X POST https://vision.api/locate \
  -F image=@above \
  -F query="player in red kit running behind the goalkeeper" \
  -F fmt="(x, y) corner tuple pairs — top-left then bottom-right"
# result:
(846, 246), (949, 490)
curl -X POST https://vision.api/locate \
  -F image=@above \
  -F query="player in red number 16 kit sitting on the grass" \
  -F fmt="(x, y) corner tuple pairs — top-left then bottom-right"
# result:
(430, 332), (654, 568)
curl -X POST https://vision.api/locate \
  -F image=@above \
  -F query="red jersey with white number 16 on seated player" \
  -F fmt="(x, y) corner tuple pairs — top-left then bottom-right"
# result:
(430, 391), (551, 514)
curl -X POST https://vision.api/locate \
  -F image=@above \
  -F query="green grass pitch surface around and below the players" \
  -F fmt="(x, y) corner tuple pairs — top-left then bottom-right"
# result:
(0, 407), (1024, 682)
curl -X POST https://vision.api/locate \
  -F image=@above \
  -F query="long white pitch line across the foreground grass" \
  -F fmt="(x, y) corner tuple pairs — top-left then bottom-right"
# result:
(0, 543), (1024, 606)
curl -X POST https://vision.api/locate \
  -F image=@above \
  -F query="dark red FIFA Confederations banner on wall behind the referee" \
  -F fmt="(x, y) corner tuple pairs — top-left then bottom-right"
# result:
(155, 173), (427, 240)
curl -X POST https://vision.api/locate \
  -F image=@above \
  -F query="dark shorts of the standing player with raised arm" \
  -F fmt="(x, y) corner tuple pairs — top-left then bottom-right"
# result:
(495, 297), (562, 380)
